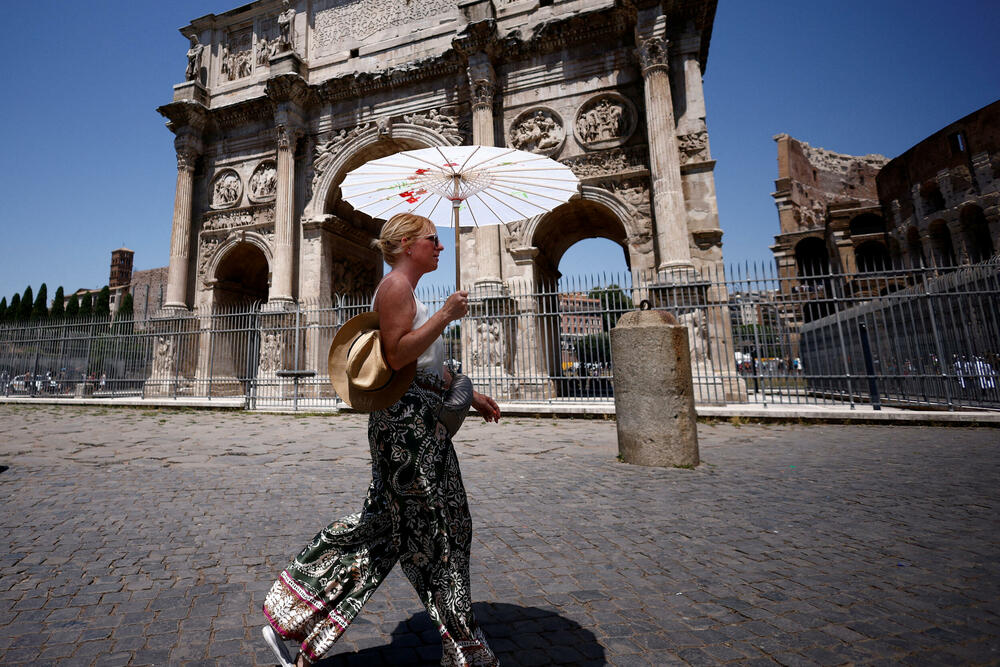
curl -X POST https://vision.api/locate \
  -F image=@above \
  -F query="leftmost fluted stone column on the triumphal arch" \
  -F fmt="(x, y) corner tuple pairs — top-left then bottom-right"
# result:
(163, 134), (202, 310)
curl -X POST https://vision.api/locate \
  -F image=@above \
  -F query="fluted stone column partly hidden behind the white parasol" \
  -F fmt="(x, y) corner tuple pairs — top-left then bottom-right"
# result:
(468, 51), (500, 288)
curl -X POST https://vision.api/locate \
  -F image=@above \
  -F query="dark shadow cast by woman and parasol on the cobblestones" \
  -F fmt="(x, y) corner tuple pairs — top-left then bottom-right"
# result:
(315, 602), (606, 667)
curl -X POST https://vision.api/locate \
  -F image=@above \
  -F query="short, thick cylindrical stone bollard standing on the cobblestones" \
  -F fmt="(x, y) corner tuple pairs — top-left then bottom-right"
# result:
(611, 310), (700, 468)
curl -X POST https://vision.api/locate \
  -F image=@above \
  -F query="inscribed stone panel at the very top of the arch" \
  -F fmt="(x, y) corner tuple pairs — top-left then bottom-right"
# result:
(310, 0), (456, 56)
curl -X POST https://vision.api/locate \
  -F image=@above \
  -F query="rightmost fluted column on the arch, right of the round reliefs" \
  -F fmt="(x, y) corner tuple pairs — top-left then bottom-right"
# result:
(635, 10), (694, 270)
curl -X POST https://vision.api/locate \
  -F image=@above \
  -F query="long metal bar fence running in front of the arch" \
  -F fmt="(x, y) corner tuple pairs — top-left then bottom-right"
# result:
(0, 259), (1000, 410)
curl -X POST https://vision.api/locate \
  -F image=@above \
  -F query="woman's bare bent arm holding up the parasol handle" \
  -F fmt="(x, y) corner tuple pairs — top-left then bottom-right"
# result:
(375, 276), (469, 370)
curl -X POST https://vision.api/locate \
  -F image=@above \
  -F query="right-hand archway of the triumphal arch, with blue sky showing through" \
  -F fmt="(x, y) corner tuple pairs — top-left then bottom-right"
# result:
(532, 199), (631, 396)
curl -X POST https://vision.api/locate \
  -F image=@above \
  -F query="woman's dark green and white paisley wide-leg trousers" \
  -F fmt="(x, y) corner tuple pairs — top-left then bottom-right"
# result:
(264, 373), (499, 666)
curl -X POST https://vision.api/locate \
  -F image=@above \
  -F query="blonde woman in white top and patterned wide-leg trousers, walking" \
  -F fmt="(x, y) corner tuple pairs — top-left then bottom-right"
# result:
(263, 213), (500, 667)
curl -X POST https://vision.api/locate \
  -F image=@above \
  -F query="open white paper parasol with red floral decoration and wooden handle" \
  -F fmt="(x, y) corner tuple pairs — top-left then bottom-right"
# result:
(340, 146), (580, 289)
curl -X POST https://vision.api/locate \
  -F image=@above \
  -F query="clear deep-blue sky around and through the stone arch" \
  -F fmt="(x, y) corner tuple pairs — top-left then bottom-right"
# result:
(0, 0), (1000, 301)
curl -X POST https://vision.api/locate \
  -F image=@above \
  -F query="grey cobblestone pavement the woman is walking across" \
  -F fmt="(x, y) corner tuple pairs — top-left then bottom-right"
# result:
(0, 405), (1000, 666)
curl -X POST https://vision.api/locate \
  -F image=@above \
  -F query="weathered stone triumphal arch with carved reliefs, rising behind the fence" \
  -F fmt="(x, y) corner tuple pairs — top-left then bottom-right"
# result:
(159, 0), (731, 402)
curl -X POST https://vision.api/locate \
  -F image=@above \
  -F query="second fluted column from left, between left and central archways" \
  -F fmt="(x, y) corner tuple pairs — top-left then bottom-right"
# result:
(268, 123), (301, 303)
